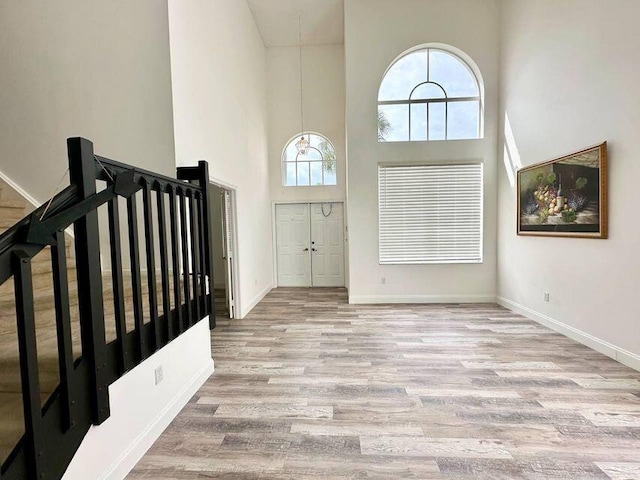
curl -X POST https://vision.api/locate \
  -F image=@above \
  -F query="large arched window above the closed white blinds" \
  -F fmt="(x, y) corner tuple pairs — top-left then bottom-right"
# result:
(378, 47), (482, 142)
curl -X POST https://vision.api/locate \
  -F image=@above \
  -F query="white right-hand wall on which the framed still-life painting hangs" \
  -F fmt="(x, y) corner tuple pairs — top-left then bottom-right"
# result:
(498, 0), (640, 360)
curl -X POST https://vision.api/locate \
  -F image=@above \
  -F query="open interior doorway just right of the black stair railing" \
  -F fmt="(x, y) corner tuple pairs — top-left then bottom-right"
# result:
(211, 183), (237, 318)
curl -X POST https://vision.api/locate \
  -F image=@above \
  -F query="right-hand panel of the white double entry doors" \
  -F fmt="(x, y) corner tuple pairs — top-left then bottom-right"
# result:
(310, 203), (344, 287)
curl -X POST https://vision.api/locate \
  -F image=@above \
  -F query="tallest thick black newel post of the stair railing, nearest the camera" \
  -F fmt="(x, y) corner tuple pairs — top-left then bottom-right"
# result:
(67, 138), (109, 425)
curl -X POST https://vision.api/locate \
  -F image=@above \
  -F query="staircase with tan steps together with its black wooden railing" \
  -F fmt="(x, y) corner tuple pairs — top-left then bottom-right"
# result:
(0, 138), (215, 480)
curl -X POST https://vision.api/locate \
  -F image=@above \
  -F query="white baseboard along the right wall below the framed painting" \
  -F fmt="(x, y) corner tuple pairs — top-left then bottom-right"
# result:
(496, 297), (640, 371)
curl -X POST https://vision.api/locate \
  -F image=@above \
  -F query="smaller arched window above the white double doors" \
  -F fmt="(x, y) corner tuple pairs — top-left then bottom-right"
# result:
(282, 133), (337, 187)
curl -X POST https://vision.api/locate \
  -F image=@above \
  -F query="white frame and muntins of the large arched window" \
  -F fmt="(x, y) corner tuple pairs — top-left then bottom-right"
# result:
(378, 45), (484, 143)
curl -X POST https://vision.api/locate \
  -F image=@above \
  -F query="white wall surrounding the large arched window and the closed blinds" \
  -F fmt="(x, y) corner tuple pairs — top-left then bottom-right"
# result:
(345, 0), (499, 302)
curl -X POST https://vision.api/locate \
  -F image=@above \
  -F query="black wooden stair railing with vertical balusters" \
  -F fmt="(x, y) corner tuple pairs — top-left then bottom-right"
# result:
(0, 138), (215, 480)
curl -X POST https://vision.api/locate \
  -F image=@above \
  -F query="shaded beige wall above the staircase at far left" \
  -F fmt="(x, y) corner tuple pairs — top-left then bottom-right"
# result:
(0, 0), (175, 199)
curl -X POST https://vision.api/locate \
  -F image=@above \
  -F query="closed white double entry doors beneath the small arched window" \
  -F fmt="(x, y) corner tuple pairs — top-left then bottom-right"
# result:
(275, 202), (345, 287)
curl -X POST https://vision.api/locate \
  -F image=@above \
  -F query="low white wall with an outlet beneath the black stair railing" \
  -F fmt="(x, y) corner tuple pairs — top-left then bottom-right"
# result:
(62, 317), (213, 480)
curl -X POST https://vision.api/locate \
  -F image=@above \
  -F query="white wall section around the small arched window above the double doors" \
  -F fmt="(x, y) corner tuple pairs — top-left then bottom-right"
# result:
(267, 45), (346, 202)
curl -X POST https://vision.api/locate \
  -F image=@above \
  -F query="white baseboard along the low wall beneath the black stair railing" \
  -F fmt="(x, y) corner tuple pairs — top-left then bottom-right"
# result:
(98, 359), (214, 480)
